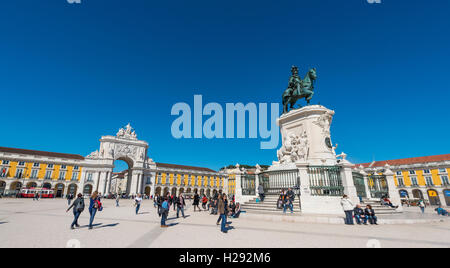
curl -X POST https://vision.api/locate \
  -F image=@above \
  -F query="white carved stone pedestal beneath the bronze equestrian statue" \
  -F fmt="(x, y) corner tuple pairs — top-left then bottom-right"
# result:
(269, 105), (358, 215)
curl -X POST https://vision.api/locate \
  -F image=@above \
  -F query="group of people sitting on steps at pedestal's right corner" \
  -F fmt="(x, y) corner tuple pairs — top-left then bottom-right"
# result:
(341, 195), (378, 225)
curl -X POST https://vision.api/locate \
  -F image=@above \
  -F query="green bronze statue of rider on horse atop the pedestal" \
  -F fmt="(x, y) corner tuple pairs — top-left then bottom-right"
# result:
(283, 66), (317, 114)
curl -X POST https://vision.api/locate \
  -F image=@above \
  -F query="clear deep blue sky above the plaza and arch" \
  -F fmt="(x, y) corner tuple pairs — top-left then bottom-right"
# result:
(0, 0), (450, 169)
